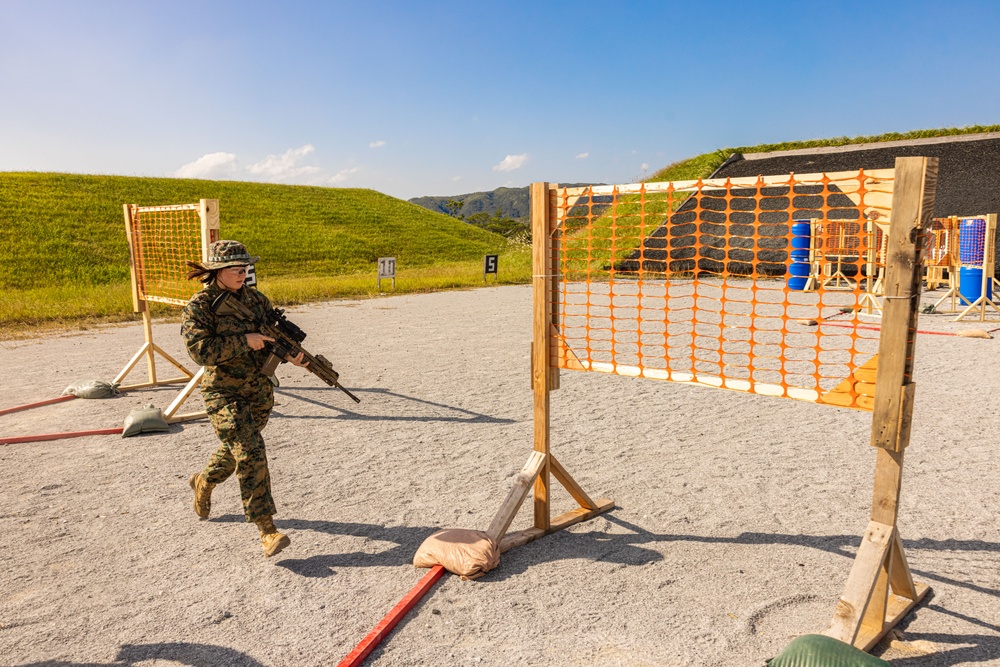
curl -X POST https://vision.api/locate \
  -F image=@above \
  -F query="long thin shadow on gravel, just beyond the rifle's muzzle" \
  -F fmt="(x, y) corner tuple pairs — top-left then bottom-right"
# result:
(271, 387), (517, 424)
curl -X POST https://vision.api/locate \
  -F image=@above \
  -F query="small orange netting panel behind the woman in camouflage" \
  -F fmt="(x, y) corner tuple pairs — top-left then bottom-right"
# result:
(130, 204), (202, 306)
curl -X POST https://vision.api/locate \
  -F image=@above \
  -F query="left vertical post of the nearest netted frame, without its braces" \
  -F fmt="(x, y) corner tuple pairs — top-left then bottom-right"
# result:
(531, 183), (552, 531)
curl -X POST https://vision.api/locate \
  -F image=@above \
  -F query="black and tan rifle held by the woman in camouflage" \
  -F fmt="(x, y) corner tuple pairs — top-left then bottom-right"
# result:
(212, 291), (361, 403)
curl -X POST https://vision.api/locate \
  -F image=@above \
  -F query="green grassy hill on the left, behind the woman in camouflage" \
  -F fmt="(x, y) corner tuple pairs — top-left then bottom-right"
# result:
(0, 172), (530, 329)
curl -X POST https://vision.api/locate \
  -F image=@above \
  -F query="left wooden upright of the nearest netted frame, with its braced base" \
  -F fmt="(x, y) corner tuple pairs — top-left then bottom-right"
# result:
(486, 183), (615, 552)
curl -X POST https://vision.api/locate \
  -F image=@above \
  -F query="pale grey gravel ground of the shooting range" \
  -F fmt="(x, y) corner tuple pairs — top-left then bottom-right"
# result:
(0, 287), (1000, 667)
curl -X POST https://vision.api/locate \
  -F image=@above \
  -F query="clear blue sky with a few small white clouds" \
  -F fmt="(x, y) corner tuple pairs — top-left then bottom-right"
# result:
(0, 0), (1000, 199)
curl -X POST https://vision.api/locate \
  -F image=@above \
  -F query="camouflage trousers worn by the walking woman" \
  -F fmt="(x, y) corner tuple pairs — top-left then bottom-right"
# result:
(201, 376), (277, 522)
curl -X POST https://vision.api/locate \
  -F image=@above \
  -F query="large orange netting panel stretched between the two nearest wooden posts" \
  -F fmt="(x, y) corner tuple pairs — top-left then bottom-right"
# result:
(549, 169), (893, 410)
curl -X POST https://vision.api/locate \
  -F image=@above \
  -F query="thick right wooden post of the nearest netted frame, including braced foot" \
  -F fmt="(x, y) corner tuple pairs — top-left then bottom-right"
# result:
(827, 157), (937, 651)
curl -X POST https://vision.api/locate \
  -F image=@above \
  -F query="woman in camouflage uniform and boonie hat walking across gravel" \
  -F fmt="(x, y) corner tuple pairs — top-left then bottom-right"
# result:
(181, 241), (290, 556)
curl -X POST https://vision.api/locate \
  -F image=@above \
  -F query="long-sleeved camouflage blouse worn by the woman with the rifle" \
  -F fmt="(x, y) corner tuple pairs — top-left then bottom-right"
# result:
(181, 283), (271, 393)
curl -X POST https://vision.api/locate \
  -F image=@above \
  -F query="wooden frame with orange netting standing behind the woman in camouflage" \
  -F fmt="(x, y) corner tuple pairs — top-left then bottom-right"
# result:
(114, 199), (220, 422)
